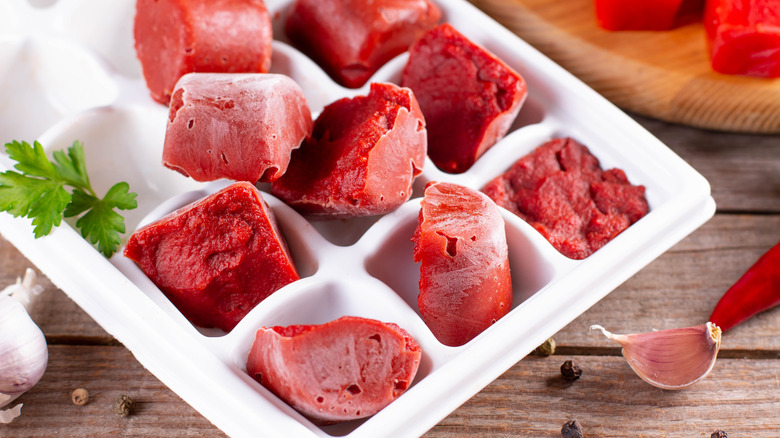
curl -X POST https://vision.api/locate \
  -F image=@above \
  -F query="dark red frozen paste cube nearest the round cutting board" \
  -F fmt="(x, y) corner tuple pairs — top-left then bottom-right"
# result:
(401, 24), (527, 173)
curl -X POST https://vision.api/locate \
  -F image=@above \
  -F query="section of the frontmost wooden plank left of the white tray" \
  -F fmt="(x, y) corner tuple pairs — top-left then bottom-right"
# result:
(0, 345), (225, 438)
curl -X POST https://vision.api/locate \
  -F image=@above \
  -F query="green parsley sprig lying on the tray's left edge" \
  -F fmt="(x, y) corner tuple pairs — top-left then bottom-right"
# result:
(0, 141), (138, 257)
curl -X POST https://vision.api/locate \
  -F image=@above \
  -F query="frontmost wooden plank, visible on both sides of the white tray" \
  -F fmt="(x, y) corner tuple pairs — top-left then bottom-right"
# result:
(7, 345), (780, 438)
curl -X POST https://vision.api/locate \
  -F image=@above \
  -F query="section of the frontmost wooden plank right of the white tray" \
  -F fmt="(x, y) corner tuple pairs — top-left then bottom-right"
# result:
(425, 356), (780, 438)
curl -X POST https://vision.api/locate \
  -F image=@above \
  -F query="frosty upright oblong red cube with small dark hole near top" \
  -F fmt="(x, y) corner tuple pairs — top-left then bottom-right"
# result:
(412, 182), (512, 346)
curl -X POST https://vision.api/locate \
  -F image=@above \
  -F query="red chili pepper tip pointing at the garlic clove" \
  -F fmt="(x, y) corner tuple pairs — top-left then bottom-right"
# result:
(710, 243), (780, 332)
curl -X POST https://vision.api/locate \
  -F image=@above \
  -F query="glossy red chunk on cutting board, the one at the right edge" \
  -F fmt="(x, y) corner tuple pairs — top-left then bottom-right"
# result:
(704, 0), (780, 78)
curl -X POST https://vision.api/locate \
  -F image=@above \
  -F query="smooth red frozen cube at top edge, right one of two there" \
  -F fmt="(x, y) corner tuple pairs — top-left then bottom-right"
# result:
(286, 0), (441, 88)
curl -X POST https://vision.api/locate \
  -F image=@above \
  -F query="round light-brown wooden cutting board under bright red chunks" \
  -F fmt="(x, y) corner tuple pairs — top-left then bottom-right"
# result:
(470, 0), (780, 134)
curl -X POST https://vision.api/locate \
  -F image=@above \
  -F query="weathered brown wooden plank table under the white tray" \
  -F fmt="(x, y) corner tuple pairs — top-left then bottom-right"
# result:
(0, 112), (780, 438)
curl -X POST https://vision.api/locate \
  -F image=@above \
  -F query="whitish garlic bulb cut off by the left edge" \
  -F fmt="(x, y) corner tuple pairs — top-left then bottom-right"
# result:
(0, 269), (49, 422)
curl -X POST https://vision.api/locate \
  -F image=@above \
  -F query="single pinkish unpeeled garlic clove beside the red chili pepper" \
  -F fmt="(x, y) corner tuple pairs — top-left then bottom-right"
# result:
(591, 322), (721, 389)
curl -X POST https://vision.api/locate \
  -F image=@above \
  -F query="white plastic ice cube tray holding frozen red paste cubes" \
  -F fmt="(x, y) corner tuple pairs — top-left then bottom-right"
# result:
(0, 0), (715, 438)
